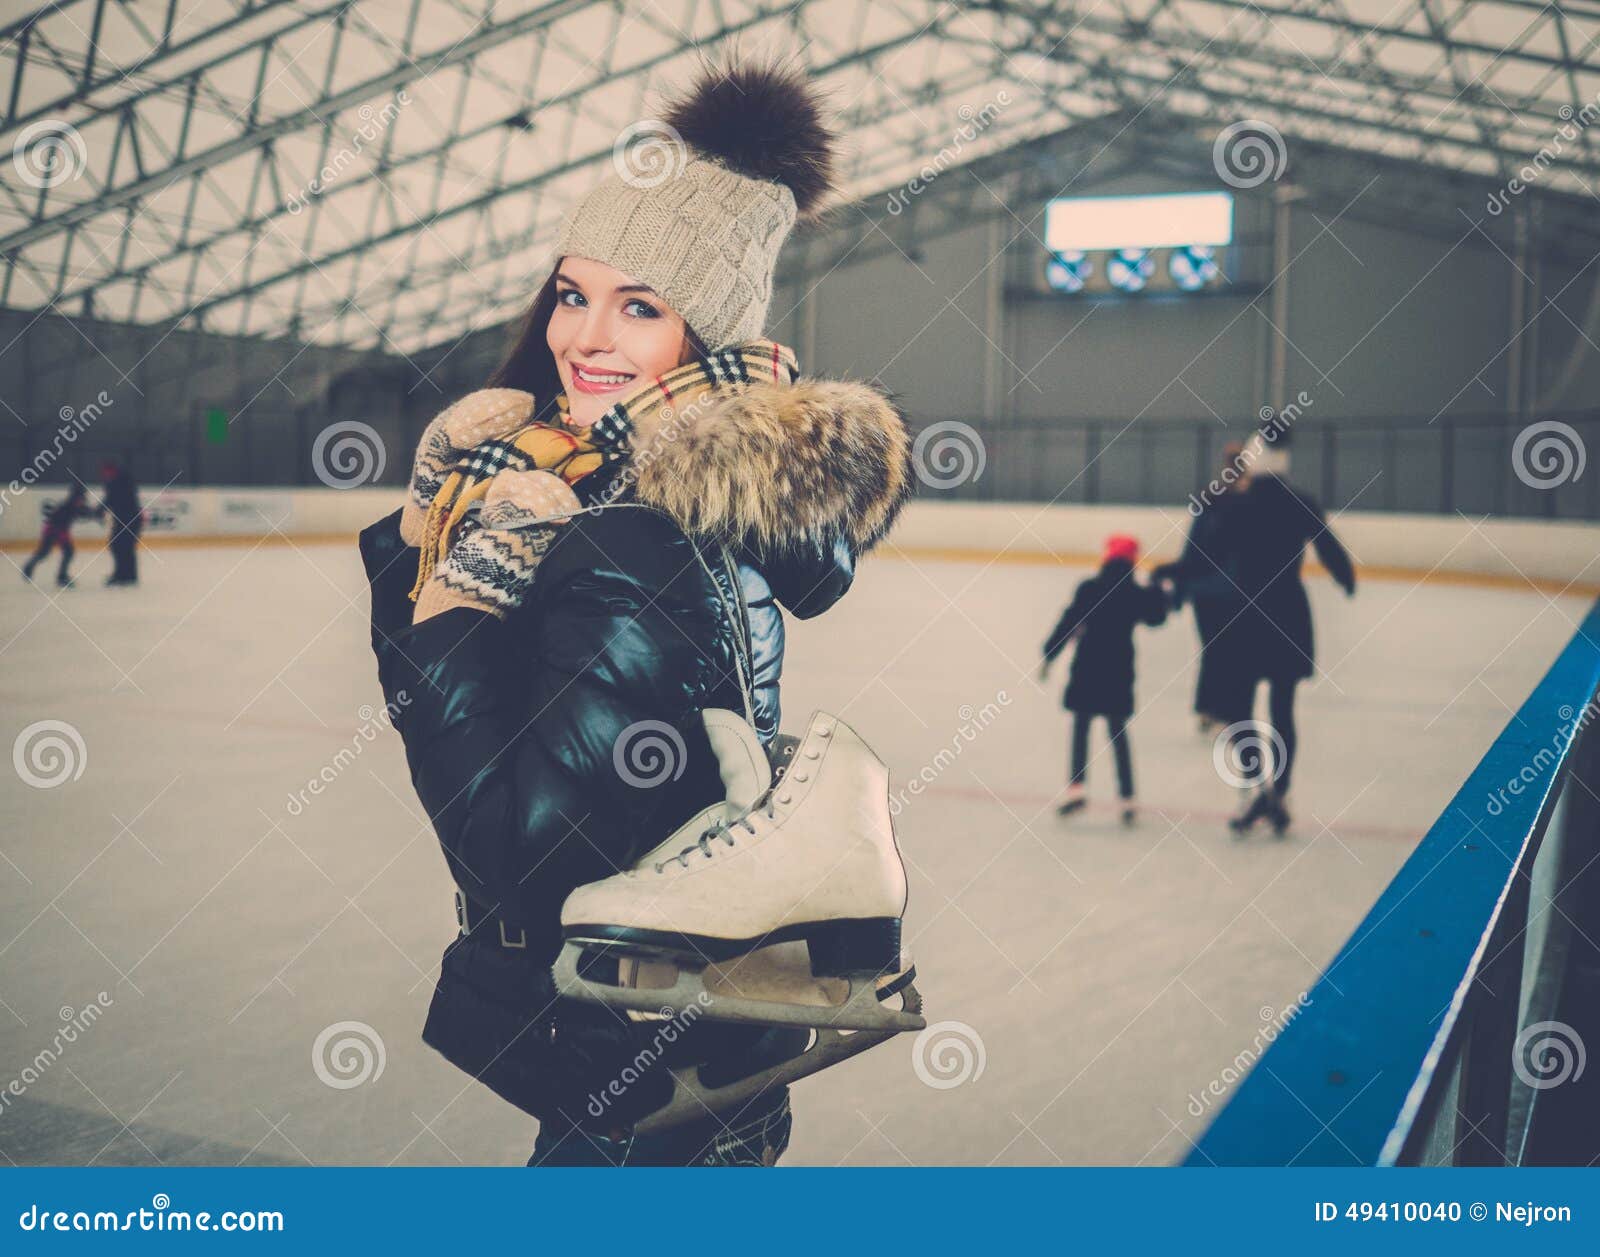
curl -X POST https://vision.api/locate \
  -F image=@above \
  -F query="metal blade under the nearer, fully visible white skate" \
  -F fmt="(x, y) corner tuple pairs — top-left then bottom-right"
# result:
(554, 942), (926, 1033)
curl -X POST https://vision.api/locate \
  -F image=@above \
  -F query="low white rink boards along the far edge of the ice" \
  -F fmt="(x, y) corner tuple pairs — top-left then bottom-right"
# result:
(0, 486), (1600, 589)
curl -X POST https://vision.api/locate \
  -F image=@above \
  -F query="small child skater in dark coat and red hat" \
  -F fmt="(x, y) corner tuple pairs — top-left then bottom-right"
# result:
(1038, 534), (1168, 825)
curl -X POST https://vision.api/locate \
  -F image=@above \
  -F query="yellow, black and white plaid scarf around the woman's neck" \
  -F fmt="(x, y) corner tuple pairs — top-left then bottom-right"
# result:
(411, 341), (800, 601)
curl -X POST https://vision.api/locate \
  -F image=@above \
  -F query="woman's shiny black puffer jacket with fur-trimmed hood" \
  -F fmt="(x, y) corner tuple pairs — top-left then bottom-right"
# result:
(362, 381), (912, 1126)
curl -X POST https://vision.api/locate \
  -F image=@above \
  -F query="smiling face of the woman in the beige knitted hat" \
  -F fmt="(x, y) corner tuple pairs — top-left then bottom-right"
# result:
(546, 257), (688, 427)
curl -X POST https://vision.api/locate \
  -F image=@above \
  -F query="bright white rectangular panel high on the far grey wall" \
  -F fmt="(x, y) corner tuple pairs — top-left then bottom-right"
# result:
(1045, 192), (1234, 254)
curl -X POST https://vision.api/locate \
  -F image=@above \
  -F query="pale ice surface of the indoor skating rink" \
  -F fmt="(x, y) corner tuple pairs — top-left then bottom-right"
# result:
(0, 544), (1587, 1164)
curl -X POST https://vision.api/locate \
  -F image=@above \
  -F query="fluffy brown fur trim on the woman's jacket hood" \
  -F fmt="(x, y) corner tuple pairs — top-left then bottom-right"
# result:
(630, 377), (915, 553)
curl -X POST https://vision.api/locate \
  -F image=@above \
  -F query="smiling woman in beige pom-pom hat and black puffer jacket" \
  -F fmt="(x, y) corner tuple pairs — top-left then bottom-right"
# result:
(362, 53), (920, 1166)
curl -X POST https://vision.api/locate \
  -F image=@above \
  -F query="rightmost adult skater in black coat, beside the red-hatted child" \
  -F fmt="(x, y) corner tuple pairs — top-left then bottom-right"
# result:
(1221, 454), (1355, 835)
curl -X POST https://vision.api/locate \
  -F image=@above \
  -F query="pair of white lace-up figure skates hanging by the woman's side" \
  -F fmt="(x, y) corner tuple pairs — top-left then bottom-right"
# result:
(555, 708), (925, 1036)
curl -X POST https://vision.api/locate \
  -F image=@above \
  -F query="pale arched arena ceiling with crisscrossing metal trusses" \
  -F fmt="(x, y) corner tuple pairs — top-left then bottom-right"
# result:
(0, 0), (1600, 353)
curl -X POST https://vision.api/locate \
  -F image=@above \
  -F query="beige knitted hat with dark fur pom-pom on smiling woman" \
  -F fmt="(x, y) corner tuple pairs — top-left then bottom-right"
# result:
(550, 64), (835, 349)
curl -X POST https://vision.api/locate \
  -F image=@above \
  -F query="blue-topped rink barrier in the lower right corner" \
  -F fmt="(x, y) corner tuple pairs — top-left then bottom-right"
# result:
(1186, 601), (1600, 1166)
